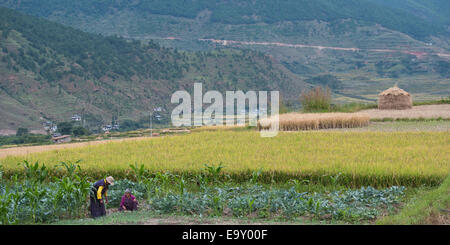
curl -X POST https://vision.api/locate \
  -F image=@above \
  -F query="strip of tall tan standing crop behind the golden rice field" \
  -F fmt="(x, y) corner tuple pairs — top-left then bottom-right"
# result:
(258, 113), (370, 131)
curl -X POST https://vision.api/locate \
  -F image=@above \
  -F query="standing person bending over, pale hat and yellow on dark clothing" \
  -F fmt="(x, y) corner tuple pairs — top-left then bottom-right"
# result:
(90, 176), (114, 218)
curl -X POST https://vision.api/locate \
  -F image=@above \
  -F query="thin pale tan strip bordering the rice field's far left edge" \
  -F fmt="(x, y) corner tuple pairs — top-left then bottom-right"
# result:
(0, 136), (151, 159)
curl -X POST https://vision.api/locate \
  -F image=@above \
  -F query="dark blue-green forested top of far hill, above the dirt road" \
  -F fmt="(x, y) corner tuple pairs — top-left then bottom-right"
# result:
(0, 0), (449, 38)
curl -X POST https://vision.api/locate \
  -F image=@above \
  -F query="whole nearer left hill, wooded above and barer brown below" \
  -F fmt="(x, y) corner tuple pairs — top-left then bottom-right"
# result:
(0, 8), (304, 129)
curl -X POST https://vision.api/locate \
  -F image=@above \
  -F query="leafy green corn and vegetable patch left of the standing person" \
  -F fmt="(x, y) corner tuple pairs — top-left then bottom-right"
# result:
(0, 162), (90, 224)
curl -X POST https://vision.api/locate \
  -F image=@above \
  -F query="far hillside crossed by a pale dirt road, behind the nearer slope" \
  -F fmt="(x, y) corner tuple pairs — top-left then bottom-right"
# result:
(0, 0), (450, 102)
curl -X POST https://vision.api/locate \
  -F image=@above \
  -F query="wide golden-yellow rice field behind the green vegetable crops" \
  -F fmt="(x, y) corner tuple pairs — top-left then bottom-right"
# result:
(0, 130), (450, 186)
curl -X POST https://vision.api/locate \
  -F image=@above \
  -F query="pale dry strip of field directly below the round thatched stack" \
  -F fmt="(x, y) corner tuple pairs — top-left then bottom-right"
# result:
(361, 104), (450, 119)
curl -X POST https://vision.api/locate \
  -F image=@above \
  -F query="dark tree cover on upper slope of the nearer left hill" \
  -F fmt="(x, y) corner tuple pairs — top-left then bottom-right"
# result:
(0, 8), (292, 92)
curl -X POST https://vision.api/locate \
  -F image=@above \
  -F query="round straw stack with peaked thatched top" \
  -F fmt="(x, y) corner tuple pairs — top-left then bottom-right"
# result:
(378, 86), (412, 110)
